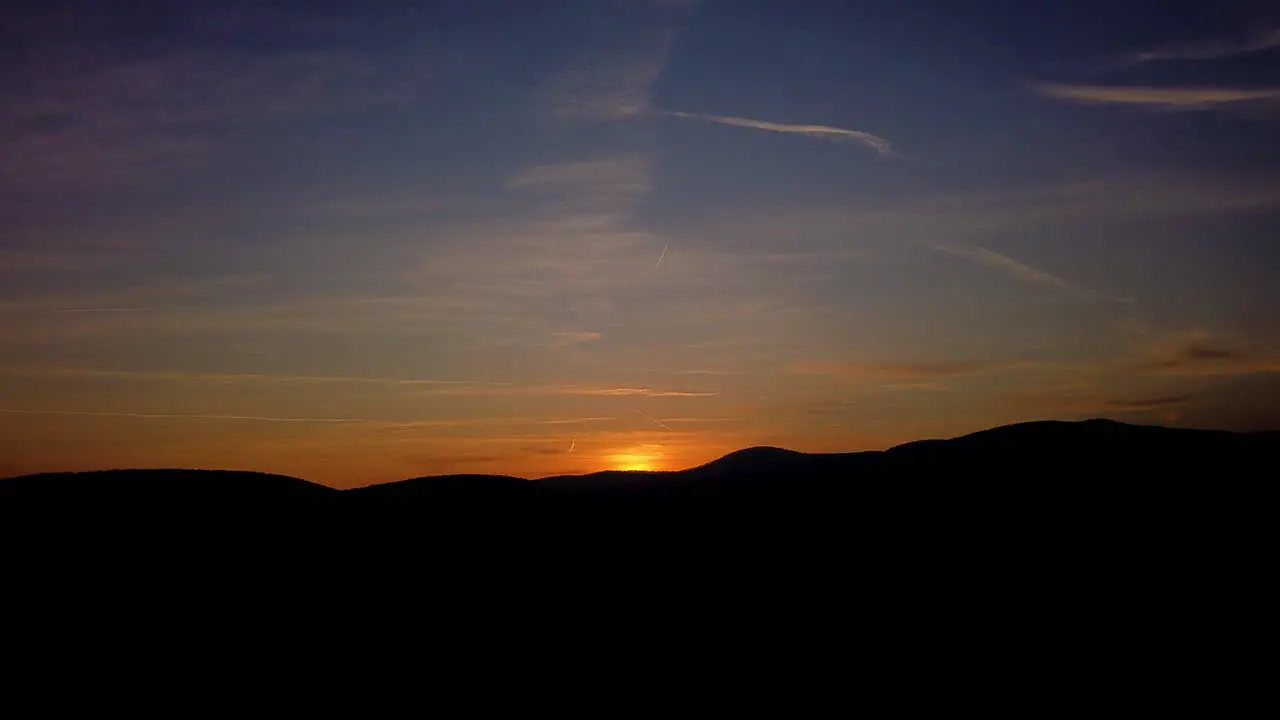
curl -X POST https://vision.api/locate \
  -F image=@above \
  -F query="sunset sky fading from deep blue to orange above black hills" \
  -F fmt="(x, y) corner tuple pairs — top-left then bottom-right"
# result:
(0, 0), (1280, 487)
